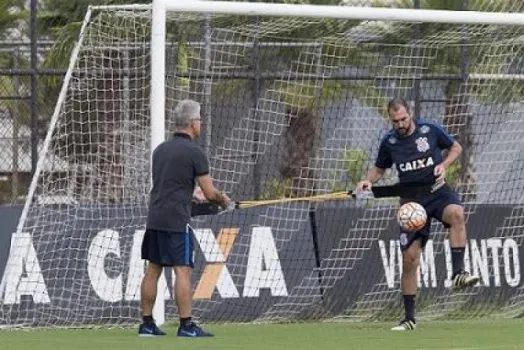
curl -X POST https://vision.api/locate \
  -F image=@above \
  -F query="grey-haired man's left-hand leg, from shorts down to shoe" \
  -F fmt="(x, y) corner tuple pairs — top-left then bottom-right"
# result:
(138, 230), (166, 337)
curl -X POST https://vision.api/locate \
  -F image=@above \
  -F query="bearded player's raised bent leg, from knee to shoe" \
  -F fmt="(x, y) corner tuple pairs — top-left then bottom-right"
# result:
(442, 204), (480, 290)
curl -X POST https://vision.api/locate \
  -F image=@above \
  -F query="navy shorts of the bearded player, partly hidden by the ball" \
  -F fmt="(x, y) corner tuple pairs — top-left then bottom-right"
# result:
(400, 185), (462, 251)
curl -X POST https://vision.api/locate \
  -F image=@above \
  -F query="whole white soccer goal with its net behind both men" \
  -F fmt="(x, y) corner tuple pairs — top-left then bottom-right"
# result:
(0, 0), (524, 327)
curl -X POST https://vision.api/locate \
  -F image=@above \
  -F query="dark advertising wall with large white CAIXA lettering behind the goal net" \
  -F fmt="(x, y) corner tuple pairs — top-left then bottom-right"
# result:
(0, 205), (524, 325)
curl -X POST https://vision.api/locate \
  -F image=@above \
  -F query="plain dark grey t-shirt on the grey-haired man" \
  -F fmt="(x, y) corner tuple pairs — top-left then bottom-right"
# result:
(146, 133), (209, 232)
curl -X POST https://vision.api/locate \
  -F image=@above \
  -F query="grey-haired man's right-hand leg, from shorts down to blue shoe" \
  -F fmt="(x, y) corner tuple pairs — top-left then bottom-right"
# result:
(170, 227), (214, 338)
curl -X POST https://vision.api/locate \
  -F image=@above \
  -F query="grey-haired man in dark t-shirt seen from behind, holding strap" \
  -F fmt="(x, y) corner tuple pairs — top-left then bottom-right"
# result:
(138, 100), (230, 337)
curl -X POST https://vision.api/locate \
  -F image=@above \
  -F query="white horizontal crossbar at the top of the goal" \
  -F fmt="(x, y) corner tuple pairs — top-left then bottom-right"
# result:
(153, 0), (524, 25)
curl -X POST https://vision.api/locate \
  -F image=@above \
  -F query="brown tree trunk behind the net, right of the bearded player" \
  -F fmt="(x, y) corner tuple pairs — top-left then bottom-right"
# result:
(443, 81), (477, 202)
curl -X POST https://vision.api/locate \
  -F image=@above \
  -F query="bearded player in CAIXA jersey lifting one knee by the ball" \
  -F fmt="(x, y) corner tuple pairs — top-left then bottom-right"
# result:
(356, 98), (479, 331)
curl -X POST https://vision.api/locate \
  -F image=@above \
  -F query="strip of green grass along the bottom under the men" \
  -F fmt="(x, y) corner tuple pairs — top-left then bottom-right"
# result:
(0, 319), (524, 350)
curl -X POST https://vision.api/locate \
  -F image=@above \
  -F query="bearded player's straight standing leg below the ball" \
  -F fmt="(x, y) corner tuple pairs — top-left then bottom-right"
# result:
(391, 224), (431, 331)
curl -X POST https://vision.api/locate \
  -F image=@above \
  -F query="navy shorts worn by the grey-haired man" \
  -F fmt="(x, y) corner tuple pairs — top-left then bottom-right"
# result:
(142, 226), (194, 268)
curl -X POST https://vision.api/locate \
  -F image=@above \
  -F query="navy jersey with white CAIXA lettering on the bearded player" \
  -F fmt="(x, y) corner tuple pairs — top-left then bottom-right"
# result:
(375, 120), (454, 185)
